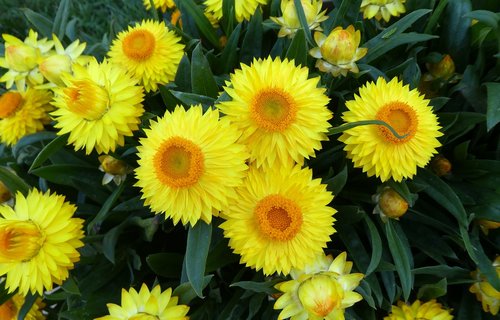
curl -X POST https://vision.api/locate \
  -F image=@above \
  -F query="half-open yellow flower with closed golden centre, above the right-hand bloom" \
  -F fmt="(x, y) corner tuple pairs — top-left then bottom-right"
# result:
(309, 25), (368, 77)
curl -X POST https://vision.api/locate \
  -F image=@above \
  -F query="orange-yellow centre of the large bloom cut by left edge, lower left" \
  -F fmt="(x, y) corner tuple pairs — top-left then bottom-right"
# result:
(0, 220), (44, 263)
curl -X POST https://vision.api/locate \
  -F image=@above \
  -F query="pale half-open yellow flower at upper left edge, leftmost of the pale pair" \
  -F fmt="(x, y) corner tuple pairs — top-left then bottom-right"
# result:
(0, 30), (54, 91)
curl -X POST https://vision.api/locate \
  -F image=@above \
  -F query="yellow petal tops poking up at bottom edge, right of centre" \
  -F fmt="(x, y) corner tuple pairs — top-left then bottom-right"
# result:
(384, 299), (453, 320)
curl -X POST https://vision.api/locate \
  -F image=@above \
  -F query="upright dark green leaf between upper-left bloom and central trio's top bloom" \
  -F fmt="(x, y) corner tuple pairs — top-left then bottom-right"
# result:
(191, 43), (219, 99)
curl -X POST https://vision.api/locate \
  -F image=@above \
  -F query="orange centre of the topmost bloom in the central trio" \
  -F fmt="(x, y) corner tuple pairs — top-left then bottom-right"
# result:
(250, 88), (297, 132)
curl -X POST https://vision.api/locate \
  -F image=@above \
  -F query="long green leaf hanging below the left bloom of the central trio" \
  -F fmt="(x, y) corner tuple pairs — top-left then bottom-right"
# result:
(185, 221), (212, 298)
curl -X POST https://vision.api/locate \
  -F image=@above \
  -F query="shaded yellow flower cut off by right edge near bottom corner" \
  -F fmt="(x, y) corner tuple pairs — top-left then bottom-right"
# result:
(469, 256), (500, 316)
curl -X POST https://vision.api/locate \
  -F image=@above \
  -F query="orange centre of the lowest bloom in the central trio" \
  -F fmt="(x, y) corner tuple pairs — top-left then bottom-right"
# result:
(254, 194), (302, 241)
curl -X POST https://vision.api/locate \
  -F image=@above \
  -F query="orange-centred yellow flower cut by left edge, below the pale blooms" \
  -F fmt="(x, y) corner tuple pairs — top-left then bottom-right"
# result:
(0, 88), (54, 146)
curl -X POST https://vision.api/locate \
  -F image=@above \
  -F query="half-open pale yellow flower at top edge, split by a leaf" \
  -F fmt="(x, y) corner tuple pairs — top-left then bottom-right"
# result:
(271, 0), (328, 38)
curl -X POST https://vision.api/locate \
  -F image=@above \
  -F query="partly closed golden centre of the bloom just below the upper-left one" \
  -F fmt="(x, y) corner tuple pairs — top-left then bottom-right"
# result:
(63, 80), (109, 121)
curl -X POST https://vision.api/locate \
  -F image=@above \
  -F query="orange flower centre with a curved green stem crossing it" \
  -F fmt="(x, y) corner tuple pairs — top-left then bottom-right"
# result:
(376, 101), (418, 143)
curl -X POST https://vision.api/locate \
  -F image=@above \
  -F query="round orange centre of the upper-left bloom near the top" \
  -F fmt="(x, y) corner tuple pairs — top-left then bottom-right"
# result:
(122, 30), (156, 61)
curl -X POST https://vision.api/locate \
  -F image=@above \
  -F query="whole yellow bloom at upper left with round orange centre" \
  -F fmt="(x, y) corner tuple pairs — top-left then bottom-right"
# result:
(108, 20), (184, 92)
